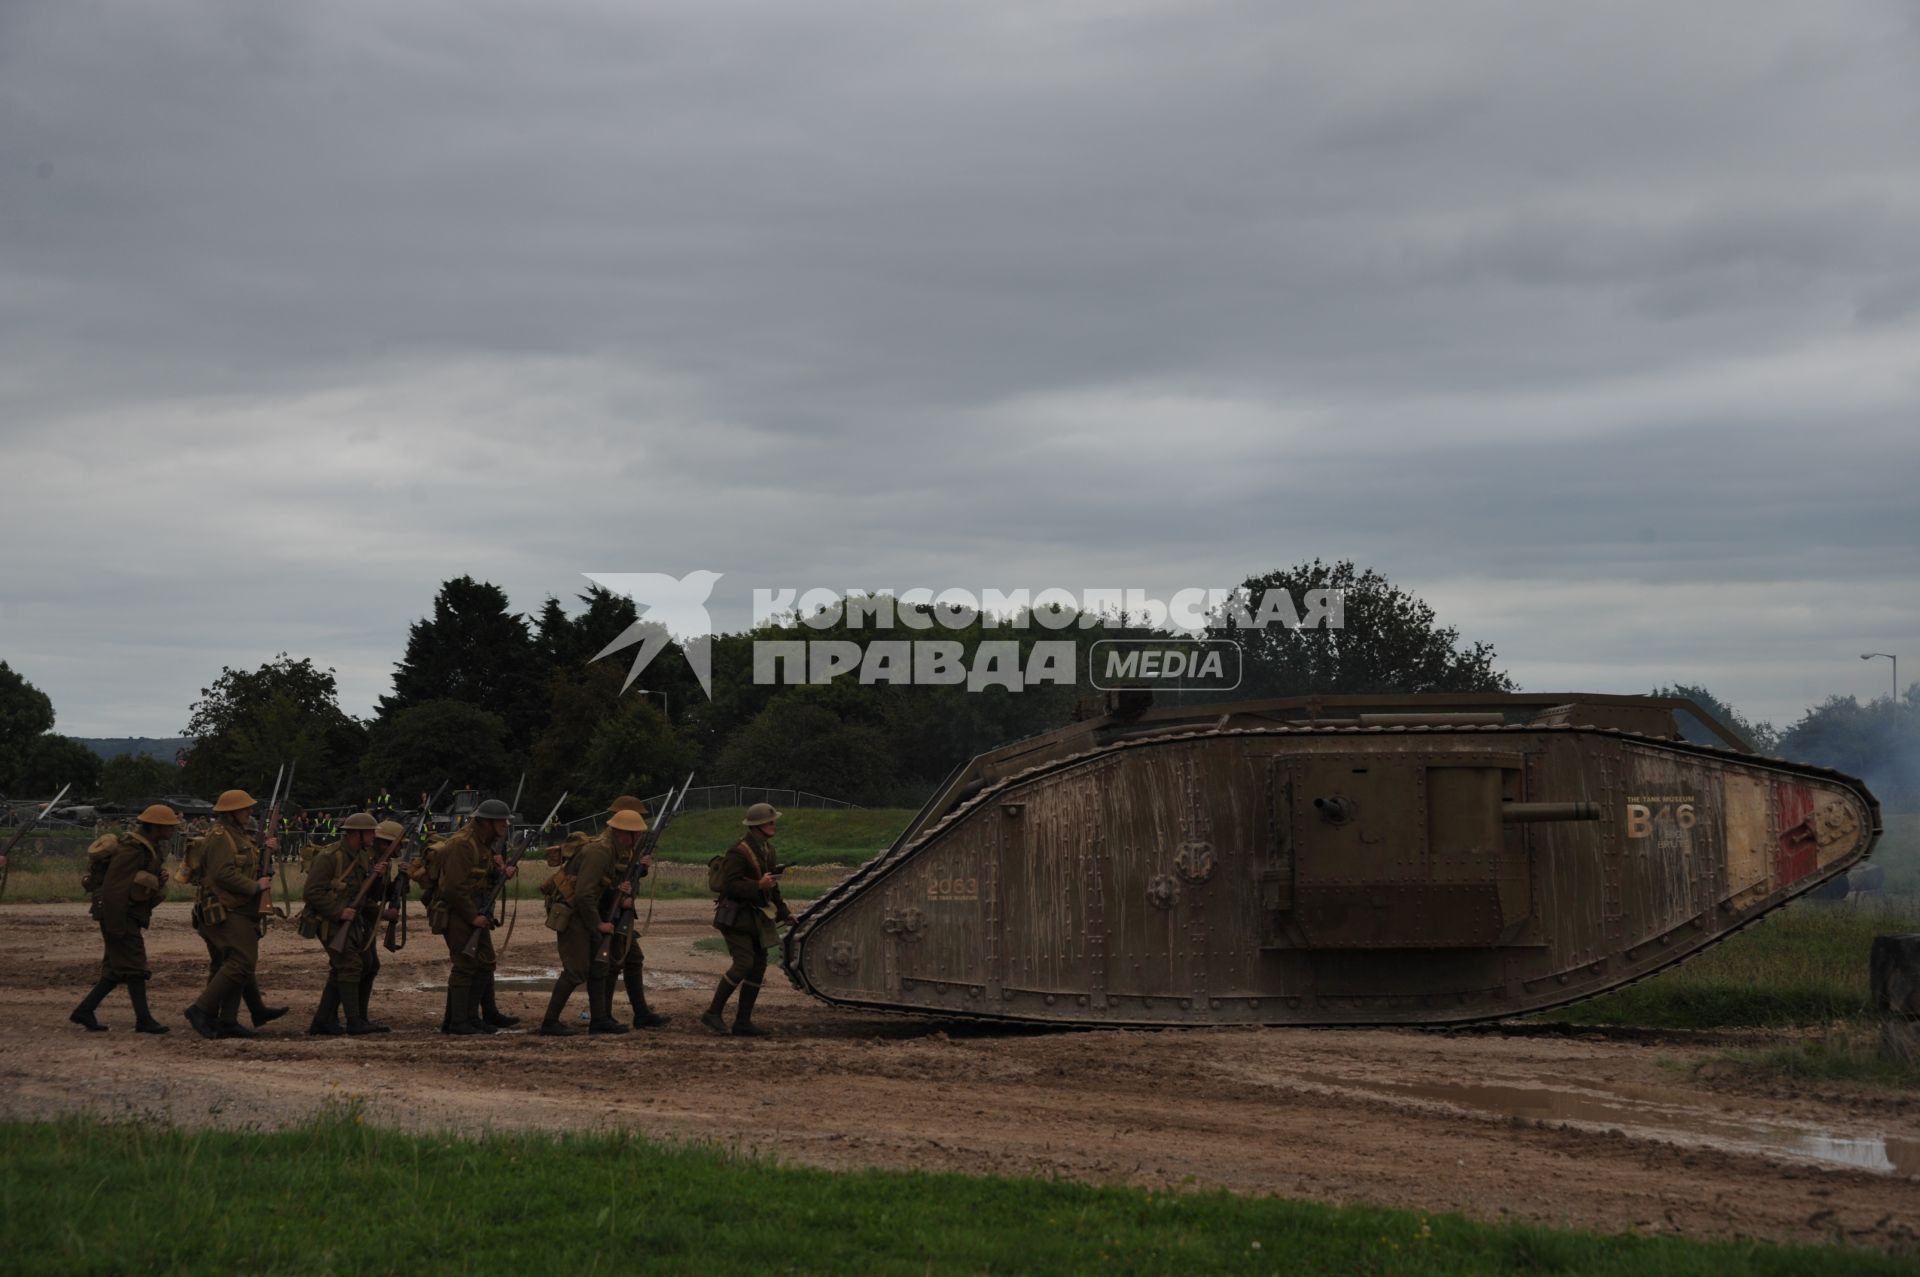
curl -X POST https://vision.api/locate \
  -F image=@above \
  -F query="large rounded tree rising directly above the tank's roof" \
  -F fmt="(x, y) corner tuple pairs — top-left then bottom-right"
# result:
(1208, 559), (1517, 699)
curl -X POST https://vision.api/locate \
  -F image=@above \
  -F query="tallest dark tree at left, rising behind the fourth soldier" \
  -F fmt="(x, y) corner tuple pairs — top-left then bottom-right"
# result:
(380, 576), (541, 753)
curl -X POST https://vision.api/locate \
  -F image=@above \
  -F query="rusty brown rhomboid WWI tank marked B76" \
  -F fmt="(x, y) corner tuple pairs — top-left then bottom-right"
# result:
(783, 693), (1880, 1025)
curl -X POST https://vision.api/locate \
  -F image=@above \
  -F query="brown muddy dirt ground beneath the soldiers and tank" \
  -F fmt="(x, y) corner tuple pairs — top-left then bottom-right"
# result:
(0, 901), (1920, 1254)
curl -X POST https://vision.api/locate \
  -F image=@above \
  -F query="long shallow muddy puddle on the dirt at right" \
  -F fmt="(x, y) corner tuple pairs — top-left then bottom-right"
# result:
(1296, 1073), (1920, 1175)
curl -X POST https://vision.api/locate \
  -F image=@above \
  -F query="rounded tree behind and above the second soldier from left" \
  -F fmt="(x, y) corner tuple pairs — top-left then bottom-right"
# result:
(180, 651), (367, 803)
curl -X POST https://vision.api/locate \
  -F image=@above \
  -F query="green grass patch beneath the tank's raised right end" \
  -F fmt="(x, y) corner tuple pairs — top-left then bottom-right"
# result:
(1542, 901), (1920, 1029)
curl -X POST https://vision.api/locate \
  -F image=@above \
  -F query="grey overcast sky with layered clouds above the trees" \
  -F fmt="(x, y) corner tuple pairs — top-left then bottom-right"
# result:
(0, 0), (1920, 735)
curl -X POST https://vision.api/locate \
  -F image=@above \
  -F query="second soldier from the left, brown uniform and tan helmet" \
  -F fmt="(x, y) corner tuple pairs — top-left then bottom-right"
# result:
(186, 789), (286, 1037)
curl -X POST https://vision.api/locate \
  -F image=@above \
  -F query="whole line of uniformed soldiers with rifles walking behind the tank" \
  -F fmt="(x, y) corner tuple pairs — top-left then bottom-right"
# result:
(69, 789), (793, 1039)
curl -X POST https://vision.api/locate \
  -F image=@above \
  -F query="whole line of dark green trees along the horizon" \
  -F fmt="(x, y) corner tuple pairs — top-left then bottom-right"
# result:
(0, 561), (1920, 814)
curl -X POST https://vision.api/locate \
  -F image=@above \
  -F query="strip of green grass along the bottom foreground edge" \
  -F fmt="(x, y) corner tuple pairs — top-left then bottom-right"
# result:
(0, 1106), (1910, 1277)
